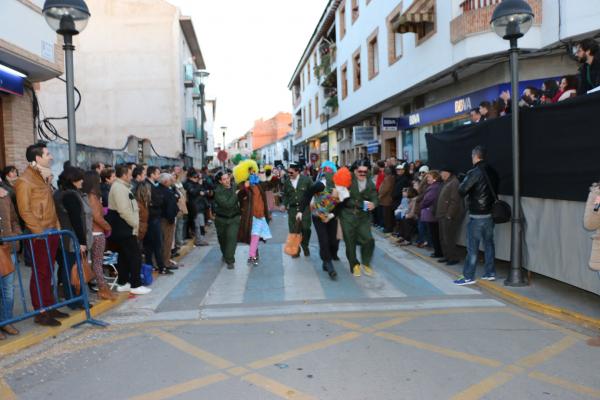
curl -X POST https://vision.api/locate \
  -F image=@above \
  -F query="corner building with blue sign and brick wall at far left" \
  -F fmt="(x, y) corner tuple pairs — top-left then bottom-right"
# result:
(0, 0), (64, 170)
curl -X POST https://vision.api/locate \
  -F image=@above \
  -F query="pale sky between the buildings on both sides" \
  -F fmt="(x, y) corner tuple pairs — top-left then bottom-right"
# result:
(168, 0), (327, 146)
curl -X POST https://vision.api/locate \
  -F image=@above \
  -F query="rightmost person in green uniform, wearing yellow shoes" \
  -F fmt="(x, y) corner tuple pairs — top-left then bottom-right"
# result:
(340, 160), (378, 277)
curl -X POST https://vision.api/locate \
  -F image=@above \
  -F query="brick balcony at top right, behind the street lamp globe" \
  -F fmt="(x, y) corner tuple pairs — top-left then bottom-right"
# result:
(450, 0), (542, 44)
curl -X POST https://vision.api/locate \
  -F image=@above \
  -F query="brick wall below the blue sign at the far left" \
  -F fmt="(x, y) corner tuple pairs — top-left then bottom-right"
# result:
(0, 93), (34, 171)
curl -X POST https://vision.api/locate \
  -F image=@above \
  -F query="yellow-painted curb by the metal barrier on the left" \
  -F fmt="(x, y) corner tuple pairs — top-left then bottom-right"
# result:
(0, 241), (194, 356)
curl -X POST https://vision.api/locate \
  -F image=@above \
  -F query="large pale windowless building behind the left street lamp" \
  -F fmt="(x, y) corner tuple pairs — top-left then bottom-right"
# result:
(40, 0), (206, 166)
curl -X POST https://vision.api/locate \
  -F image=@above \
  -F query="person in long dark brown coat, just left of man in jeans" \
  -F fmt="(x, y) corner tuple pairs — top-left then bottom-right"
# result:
(435, 167), (465, 265)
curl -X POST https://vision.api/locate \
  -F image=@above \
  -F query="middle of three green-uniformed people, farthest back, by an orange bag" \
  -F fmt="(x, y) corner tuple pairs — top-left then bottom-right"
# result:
(282, 164), (313, 258)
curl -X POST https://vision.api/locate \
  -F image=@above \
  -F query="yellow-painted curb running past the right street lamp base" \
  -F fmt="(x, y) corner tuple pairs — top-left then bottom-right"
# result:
(403, 247), (600, 329)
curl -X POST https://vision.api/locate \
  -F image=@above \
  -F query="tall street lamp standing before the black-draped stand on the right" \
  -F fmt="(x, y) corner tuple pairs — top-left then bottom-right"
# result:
(490, 0), (534, 286)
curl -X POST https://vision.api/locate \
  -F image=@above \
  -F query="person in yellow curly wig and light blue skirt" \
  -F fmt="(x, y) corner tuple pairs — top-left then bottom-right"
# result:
(233, 160), (273, 266)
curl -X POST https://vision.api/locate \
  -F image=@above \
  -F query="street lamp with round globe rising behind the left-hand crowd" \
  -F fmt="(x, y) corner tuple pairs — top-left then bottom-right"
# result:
(42, 0), (90, 166)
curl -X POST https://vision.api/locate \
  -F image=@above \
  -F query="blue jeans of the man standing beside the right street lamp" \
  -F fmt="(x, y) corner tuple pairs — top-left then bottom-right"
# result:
(463, 216), (496, 279)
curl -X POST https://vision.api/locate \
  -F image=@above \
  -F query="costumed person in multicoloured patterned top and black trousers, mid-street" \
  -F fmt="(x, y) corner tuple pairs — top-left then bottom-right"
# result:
(300, 161), (352, 280)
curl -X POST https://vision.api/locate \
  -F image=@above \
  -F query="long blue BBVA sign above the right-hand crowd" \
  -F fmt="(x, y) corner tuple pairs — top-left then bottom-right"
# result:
(398, 78), (558, 129)
